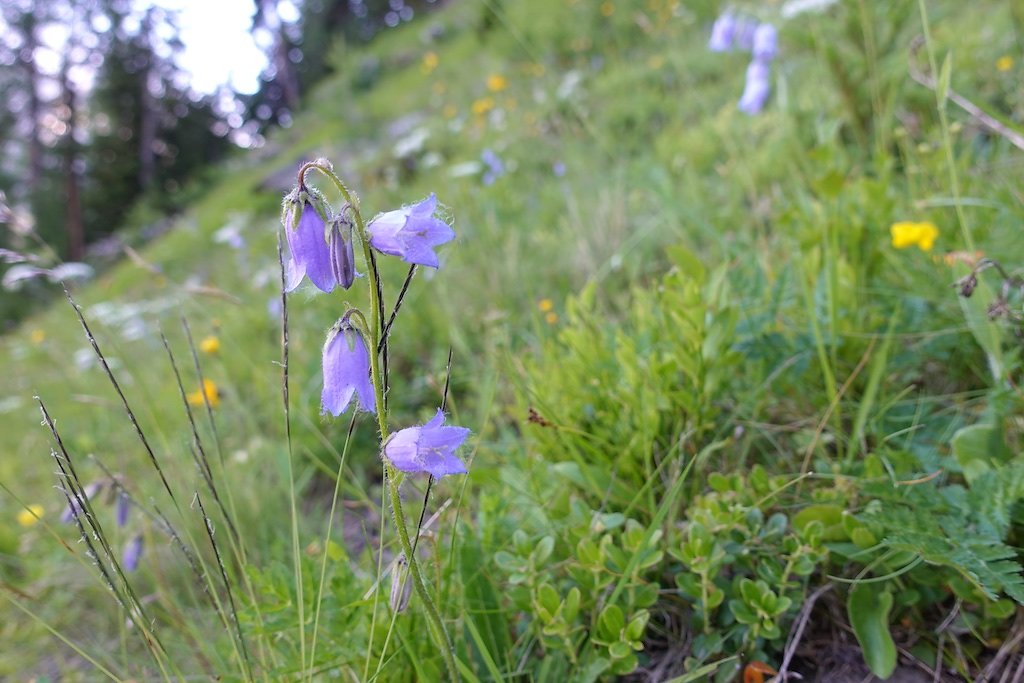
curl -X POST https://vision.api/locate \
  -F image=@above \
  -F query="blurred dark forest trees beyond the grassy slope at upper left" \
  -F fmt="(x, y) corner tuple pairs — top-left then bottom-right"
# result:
(0, 0), (434, 330)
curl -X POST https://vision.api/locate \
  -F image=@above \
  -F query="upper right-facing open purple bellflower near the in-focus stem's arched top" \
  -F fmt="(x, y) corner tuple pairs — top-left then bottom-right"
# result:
(367, 193), (455, 268)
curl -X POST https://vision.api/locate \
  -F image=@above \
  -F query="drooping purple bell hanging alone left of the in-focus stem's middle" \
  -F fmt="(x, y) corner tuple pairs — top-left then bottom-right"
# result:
(321, 316), (377, 417)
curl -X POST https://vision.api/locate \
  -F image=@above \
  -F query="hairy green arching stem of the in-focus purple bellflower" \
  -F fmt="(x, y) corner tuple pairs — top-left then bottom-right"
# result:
(299, 162), (461, 681)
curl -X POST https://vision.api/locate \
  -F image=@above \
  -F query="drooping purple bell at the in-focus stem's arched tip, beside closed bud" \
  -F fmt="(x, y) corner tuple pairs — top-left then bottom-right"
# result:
(283, 188), (338, 292)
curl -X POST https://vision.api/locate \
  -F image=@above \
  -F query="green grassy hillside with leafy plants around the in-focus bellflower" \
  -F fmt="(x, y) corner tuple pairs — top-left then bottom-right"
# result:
(0, 0), (1024, 681)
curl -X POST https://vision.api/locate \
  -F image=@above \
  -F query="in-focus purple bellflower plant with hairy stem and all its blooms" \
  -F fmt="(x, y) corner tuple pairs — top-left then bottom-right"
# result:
(282, 159), (469, 680)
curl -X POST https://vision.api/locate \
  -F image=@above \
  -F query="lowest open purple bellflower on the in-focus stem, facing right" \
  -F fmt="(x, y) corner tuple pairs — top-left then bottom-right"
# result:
(384, 411), (469, 479)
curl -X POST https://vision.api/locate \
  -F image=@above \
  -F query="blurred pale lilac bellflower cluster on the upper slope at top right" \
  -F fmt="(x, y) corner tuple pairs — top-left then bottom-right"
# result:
(708, 12), (778, 116)
